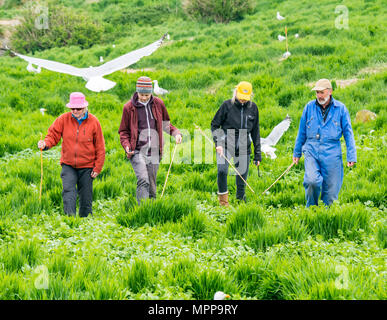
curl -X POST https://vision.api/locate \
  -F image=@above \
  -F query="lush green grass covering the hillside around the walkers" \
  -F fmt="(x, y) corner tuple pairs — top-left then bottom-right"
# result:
(0, 0), (387, 299)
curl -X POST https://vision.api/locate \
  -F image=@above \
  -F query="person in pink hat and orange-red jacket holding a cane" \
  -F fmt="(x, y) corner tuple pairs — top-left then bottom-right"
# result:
(38, 92), (105, 217)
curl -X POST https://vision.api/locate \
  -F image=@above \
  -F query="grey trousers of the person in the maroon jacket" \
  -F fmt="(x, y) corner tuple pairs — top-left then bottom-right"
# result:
(130, 150), (159, 204)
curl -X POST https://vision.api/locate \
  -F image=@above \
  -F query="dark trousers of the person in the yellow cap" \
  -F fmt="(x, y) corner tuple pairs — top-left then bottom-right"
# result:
(216, 152), (250, 200)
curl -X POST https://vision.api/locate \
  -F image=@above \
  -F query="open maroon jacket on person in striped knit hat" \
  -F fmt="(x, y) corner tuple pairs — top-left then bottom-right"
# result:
(118, 97), (181, 156)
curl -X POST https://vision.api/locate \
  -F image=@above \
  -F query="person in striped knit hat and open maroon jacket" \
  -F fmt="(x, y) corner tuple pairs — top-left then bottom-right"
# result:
(118, 76), (182, 204)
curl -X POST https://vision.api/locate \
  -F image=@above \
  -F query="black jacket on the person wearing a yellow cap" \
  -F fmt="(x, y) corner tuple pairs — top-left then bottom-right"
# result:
(211, 99), (262, 161)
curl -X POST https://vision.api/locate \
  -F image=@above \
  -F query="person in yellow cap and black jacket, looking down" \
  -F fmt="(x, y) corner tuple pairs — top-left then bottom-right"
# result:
(211, 81), (261, 206)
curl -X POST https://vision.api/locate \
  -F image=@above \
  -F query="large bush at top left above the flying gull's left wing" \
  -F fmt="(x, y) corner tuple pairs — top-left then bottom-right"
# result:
(11, 3), (103, 52)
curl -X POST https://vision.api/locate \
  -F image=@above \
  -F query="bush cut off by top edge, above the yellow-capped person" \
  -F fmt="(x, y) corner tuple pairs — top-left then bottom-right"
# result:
(184, 0), (254, 23)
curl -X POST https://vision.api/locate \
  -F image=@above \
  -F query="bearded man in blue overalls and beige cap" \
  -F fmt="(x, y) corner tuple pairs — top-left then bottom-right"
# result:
(293, 79), (356, 207)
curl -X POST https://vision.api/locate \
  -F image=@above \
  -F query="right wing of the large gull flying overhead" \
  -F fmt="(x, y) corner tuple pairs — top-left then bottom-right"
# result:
(89, 33), (171, 77)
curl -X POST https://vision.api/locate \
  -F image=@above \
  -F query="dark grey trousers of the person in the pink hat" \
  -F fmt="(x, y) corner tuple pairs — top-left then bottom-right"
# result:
(60, 164), (93, 217)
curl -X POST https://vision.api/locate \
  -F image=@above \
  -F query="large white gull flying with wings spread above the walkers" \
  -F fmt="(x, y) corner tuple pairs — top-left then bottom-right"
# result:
(6, 33), (167, 92)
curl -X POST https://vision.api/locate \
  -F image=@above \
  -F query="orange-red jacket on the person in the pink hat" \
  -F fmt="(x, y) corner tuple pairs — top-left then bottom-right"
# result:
(44, 112), (105, 173)
